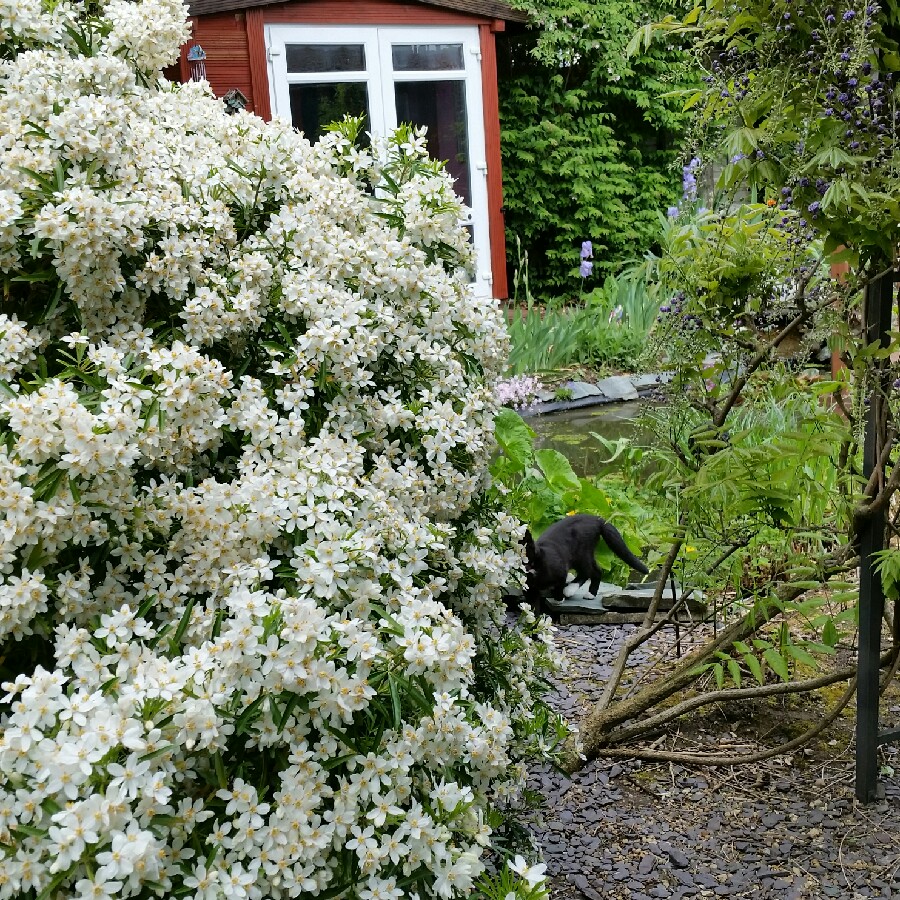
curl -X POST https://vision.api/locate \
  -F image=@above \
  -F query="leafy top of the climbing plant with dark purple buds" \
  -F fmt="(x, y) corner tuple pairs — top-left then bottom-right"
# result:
(632, 0), (900, 268)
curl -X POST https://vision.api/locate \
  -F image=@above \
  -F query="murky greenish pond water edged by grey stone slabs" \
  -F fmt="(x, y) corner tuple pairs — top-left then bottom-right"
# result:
(527, 400), (646, 477)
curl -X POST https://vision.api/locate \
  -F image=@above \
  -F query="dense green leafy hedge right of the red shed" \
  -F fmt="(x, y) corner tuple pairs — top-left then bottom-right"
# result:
(499, 0), (691, 299)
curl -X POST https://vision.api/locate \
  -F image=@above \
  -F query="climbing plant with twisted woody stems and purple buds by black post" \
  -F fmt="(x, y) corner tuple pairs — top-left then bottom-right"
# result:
(536, 0), (900, 764)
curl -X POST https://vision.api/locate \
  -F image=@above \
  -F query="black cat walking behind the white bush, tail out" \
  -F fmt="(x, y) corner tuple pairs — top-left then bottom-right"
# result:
(525, 513), (650, 612)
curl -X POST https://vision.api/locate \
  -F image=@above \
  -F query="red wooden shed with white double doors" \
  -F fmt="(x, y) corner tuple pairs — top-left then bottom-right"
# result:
(180, 0), (526, 298)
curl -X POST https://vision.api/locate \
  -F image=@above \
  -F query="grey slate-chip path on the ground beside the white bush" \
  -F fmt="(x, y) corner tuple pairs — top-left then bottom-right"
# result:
(533, 625), (900, 900)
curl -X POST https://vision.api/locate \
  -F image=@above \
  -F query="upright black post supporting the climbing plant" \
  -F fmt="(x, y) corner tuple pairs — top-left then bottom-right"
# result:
(856, 273), (894, 803)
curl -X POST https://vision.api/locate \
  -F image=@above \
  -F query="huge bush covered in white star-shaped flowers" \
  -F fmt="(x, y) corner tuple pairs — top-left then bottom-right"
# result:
(0, 0), (565, 900)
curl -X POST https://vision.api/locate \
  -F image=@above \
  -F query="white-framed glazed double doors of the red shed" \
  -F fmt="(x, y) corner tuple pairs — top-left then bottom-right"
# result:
(266, 25), (492, 295)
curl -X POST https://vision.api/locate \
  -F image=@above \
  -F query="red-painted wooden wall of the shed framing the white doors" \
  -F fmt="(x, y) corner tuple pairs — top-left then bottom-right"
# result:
(181, 0), (508, 298)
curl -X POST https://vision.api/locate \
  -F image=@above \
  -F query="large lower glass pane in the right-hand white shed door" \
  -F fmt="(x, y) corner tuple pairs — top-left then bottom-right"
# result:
(394, 81), (472, 206)
